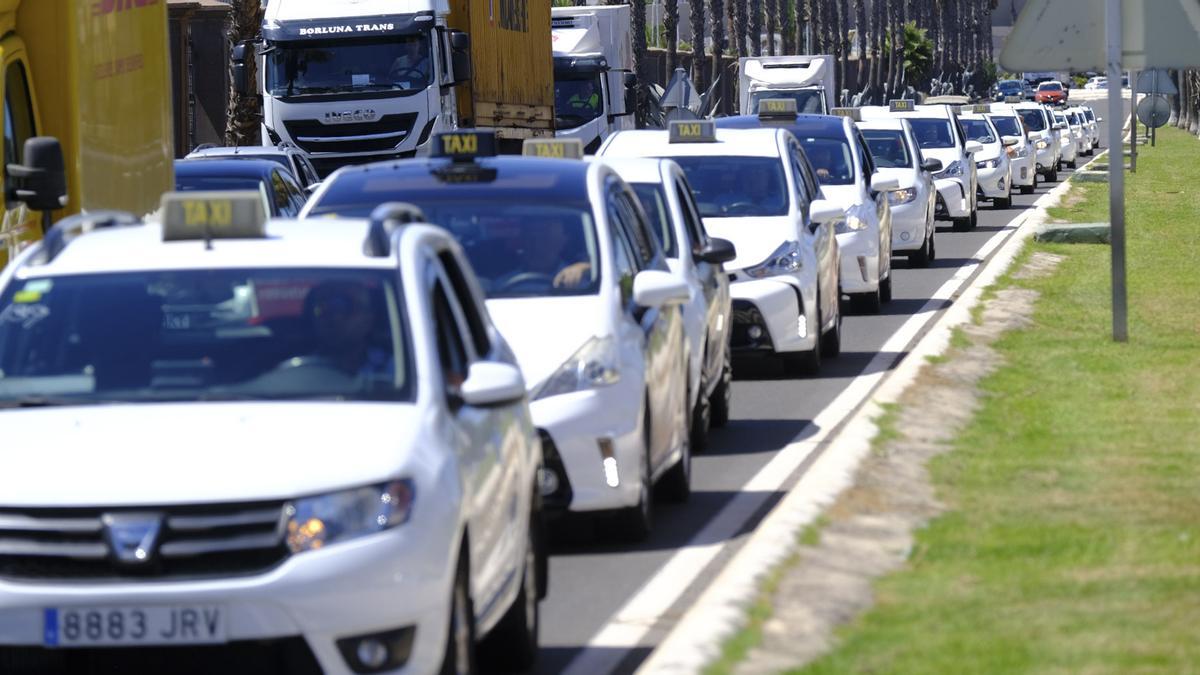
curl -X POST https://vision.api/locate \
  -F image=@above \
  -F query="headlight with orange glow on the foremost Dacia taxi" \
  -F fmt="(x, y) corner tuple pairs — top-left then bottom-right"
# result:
(284, 479), (416, 554)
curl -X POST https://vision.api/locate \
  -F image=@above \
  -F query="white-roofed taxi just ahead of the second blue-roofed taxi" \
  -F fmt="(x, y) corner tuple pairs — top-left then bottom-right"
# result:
(599, 120), (844, 372)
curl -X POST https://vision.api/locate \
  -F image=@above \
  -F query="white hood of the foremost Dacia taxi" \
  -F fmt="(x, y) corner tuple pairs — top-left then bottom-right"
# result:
(0, 401), (421, 507)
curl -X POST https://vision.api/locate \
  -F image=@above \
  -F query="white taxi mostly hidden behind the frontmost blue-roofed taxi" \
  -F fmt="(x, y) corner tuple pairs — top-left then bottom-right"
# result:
(595, 152), (737, 450)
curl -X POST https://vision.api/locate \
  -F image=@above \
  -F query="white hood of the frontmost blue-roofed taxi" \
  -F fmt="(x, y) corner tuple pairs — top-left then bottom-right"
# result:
(487, 295), (605, 392)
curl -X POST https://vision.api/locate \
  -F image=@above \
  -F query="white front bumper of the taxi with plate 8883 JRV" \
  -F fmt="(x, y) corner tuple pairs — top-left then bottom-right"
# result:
(0, 528), (454, 674)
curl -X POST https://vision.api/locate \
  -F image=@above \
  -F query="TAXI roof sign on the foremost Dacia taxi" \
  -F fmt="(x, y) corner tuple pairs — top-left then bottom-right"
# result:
(162, 190), (269, 241)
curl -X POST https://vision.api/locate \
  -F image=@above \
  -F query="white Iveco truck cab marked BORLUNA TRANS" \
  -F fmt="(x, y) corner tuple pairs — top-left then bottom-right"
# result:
(241, 0), (470, 174)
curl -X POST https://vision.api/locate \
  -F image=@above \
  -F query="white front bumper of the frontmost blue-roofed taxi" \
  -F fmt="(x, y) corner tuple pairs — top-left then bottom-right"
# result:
(529, 377), (646, 512)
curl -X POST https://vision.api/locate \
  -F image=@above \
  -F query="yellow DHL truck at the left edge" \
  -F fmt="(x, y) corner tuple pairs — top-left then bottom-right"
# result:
(0, 0), (174, 264)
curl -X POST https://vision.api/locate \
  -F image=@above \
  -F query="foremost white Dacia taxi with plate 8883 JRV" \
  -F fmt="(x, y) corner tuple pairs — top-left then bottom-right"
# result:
(0, 192), (546, 674)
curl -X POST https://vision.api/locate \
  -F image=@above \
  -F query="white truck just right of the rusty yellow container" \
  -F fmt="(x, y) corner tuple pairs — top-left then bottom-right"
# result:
(551, 5), (636, 155)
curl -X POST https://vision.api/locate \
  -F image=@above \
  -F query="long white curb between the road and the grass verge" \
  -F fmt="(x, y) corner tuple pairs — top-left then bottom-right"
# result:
(637, 177), (1080, 674)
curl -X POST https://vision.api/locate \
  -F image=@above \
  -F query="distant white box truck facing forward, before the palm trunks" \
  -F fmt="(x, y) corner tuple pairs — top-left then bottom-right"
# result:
(738, 55), (838, 115)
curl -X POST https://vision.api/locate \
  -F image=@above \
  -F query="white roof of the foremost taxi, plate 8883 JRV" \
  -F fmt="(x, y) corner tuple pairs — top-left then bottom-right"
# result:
(16, 219), (397, 277)
